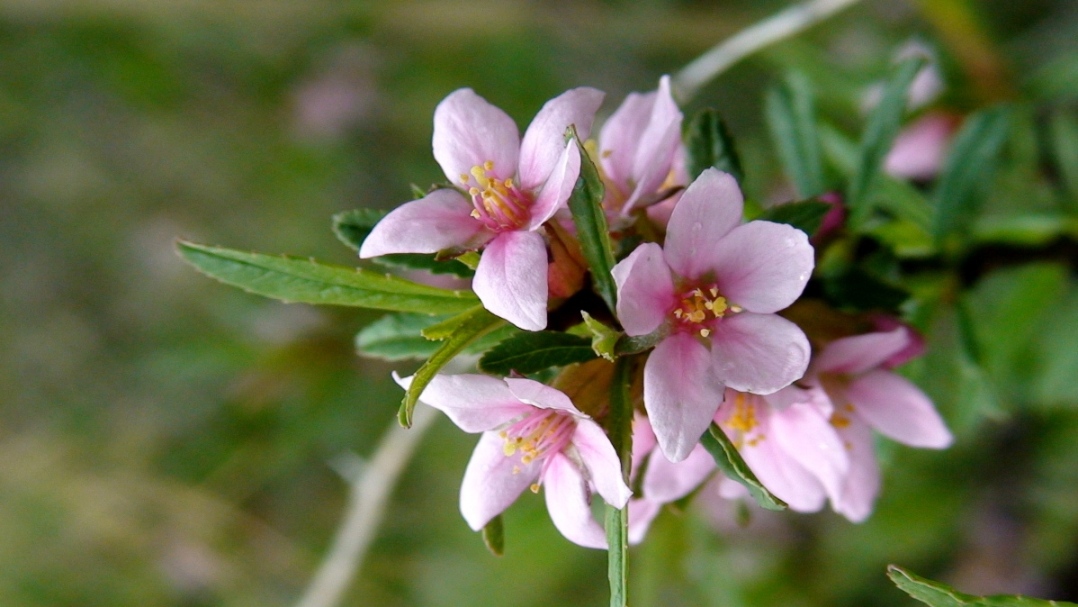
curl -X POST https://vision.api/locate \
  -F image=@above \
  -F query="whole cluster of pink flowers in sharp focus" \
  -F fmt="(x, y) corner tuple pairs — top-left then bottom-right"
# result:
(360, 78), (951, 548)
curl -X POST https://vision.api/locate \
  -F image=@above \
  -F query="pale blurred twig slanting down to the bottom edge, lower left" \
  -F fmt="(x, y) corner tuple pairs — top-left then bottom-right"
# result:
(296, 406), (437, 607)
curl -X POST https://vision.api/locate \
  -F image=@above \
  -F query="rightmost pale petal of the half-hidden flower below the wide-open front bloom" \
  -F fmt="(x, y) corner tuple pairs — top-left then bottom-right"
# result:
(769, 404), (849, 501)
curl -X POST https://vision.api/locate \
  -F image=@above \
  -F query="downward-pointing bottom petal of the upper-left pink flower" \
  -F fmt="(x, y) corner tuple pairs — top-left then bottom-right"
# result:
(472, 232), (547, 331)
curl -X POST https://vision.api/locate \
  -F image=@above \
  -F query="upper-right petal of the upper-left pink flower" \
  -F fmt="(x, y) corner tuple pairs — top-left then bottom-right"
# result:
(519, 86), (603, 190)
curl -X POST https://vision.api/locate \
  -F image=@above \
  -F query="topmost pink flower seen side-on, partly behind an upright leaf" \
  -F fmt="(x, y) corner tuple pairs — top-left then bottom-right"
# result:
(598, 75), (681, 216)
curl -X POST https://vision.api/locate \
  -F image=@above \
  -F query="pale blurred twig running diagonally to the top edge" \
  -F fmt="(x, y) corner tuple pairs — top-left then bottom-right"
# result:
(673, 0), (860, 104)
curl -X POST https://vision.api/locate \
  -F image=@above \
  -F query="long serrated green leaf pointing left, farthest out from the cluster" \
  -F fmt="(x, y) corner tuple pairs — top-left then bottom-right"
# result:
(177, 242), (479, 314)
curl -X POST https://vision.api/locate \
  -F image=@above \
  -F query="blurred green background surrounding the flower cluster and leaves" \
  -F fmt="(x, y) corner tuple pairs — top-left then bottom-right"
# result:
(0, 0), (1078, 607)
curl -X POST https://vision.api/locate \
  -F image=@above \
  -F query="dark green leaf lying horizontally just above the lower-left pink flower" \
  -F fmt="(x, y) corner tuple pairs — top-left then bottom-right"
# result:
(479, 331), (595, 375)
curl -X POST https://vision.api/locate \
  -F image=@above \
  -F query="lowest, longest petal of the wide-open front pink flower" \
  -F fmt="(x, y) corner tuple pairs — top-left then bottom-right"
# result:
(644, 333), (723, 461)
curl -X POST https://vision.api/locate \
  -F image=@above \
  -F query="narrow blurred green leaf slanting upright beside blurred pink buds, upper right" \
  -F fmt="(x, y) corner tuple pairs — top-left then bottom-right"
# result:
(846, 57), (925, 226)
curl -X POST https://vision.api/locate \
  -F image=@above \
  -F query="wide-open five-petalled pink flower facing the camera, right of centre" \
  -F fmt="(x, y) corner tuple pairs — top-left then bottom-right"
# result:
(612, 169), (813, 461)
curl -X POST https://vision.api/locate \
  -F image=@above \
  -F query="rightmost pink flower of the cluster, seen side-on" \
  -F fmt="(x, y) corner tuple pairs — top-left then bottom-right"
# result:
(807, 326), (953, 522)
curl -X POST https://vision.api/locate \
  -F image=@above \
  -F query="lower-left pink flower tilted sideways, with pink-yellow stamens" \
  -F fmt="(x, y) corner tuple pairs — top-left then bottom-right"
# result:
(401, 375), (632, 548)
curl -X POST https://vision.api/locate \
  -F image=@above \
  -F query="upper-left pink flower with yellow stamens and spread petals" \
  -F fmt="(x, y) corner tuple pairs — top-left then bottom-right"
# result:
(359, 87), (603, 331)
